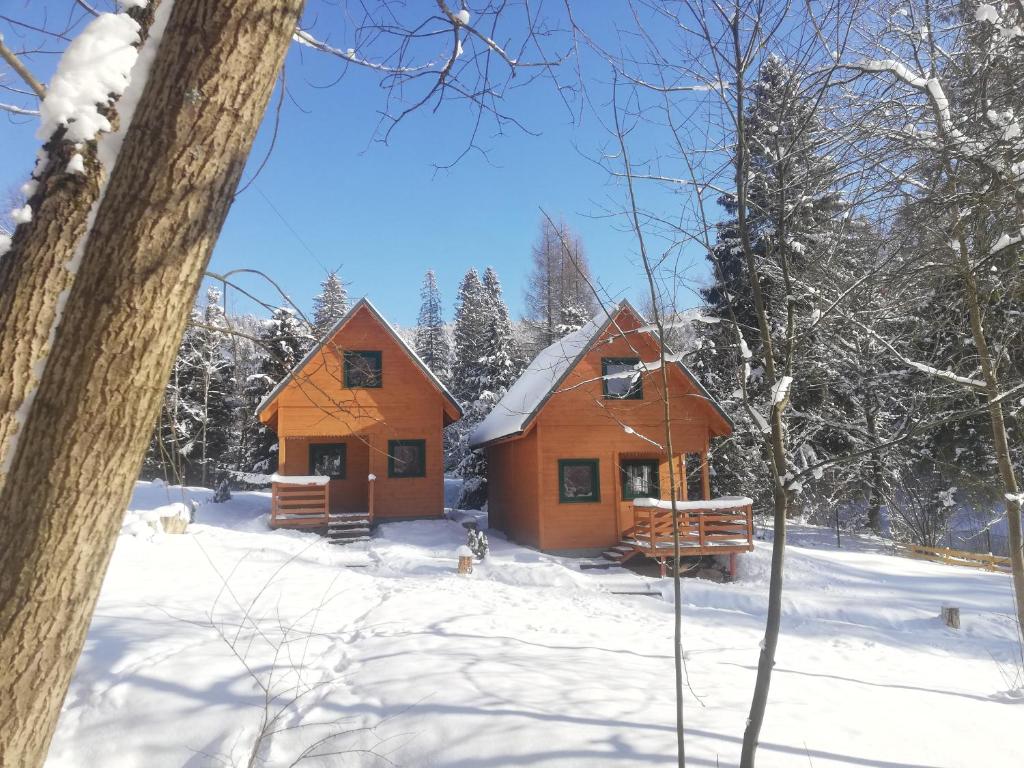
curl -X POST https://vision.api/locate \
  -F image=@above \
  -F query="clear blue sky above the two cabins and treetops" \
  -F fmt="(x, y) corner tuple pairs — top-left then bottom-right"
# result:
(0, 4), (705, 325)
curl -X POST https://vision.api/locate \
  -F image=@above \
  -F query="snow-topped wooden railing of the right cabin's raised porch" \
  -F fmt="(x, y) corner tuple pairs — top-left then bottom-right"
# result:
(631, 499), (754, 555)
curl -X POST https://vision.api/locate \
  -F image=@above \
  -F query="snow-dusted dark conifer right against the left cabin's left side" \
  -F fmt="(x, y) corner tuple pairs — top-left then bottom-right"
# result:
(245, 307), (313, 474)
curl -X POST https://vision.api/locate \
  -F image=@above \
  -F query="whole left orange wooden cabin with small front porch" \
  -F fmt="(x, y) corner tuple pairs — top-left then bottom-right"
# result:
(256, 299), (462, 540)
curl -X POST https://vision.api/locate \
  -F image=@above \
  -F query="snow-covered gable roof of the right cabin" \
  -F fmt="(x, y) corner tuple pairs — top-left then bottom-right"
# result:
(469, 299), (733, 449)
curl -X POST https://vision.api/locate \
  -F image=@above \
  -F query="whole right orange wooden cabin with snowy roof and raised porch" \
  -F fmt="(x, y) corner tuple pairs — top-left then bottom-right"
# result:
(470, 301), (753, 567)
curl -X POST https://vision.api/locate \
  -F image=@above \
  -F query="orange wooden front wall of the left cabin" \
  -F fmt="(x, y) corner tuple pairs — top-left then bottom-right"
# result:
(271, 307), (445, 518)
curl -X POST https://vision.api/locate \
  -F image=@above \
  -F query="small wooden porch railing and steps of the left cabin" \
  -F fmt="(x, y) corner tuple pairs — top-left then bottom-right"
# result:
(270, 474), (377, 544)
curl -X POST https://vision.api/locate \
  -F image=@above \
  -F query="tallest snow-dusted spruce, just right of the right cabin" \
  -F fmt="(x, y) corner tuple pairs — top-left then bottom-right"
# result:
(697, 56), (852, 518)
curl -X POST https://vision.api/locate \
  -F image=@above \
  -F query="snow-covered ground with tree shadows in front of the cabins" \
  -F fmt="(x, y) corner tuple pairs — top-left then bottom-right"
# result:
(48, 483), (1024, 768)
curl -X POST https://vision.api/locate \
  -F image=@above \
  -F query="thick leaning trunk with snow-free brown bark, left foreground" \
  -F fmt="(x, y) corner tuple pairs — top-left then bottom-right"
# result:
(0, 0), (302, 768)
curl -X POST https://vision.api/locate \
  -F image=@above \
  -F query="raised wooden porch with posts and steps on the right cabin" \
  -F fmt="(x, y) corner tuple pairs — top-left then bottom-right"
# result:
(614, 497), (754, 575)
